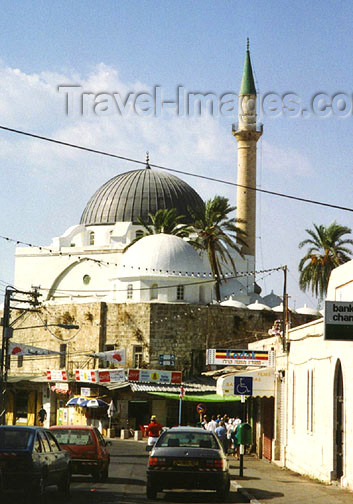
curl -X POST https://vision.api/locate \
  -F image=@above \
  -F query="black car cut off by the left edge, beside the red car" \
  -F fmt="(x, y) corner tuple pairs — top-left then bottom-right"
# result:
(0, 425), (71, 502)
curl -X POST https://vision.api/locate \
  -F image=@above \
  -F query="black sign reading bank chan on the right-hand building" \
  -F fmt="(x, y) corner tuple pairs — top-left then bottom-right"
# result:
(325, 301), (353, 341)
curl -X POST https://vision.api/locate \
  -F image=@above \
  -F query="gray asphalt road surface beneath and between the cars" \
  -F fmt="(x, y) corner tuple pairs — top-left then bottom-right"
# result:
(1, 439), (248, 504)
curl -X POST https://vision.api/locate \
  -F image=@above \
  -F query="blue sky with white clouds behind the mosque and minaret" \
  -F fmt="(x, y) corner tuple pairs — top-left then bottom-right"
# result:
(0, 0), (353, 307)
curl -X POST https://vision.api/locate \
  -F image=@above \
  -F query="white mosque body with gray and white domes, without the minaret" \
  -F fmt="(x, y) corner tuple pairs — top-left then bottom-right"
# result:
(15, 165), (256, 304)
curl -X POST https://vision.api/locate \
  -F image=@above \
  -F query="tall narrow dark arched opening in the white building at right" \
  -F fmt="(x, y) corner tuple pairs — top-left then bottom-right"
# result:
(332, 359), (345, 480)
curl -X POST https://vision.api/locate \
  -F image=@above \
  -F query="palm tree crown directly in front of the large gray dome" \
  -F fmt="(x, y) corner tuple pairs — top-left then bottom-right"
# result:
(124, 208), (192, 252)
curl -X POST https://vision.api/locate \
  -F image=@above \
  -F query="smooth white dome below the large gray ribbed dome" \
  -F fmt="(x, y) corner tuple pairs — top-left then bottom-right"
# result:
(117, 233), (211, 278)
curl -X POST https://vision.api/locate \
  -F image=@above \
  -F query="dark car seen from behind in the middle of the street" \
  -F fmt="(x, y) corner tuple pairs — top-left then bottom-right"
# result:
(146, 427), (230, 499)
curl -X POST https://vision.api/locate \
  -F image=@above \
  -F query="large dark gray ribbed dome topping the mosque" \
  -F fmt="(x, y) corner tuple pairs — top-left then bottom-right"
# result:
(80, 168), (203, 226)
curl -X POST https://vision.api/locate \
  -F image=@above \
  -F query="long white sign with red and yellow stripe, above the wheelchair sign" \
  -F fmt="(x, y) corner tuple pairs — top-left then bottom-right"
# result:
(206, 348), (274, 367)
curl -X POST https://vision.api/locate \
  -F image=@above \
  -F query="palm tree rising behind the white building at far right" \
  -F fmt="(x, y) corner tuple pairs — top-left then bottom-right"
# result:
(298, 221), (353, 299)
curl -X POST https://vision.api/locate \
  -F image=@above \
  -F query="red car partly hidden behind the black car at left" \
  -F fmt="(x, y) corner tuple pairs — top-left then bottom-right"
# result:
(50, 425), (110, 481)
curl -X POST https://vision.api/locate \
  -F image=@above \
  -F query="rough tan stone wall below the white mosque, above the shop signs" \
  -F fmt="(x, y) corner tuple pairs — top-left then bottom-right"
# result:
(6, 302), (313, 376)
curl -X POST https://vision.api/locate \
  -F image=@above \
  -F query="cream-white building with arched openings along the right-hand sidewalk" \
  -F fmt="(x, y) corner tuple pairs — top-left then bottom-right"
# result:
(249, 260), (353, 490)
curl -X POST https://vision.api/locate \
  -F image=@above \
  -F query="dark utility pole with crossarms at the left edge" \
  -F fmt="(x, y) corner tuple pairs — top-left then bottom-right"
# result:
(0, 285), (41, 425)
